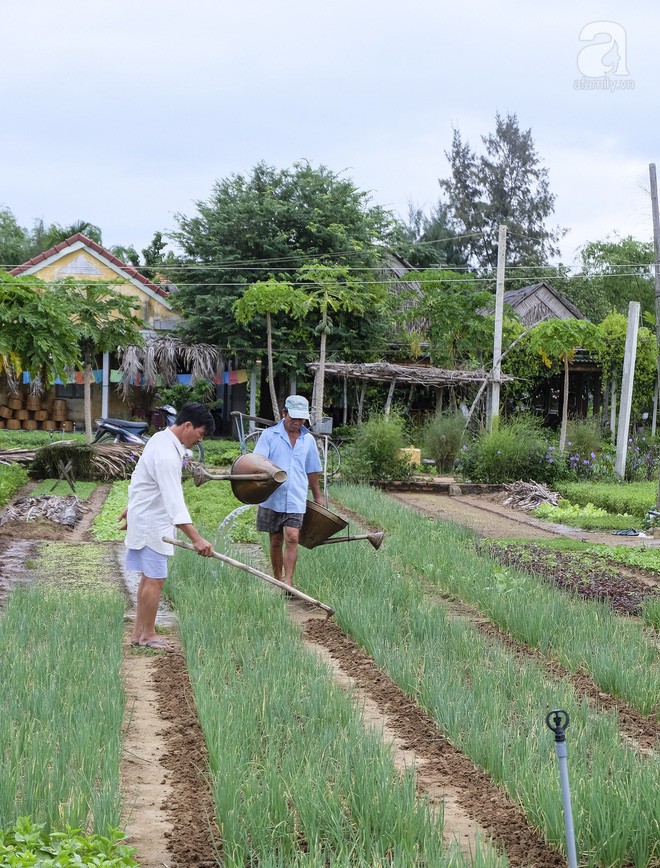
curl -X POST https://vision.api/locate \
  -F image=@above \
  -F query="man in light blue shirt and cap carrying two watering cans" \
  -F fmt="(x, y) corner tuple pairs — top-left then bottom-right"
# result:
(254, 395), (322, 587)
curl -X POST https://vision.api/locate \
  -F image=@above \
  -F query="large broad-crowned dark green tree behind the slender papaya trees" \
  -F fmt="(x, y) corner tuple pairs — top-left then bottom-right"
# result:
(167, 162), (396, 371)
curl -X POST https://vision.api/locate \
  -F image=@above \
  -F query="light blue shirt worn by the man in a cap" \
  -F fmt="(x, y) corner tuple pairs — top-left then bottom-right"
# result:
(254, 420), (323, 513)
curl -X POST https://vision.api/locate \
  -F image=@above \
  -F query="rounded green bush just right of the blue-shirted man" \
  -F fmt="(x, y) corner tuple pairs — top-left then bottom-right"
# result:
(341, 412), (413, 482)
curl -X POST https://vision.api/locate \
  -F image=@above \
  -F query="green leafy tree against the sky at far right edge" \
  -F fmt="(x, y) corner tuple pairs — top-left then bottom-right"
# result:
(563, 235), (655, 322)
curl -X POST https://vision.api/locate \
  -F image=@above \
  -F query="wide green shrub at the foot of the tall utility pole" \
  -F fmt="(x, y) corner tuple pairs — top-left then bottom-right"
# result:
(458, 417), (561, 484)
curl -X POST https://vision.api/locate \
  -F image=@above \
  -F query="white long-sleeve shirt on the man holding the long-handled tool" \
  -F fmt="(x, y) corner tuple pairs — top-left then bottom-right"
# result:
(125, 428), (192, 555)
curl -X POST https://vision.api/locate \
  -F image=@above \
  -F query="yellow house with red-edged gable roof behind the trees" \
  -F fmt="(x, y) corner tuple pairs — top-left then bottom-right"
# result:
(10, 232), (181, 425)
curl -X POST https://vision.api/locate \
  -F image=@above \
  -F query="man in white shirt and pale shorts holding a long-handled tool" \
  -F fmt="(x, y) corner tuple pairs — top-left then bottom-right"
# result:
(120, 402), (215, 651)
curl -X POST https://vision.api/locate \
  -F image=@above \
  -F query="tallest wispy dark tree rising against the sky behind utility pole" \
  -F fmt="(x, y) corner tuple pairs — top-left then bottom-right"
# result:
(440, 114), (565, 270)
